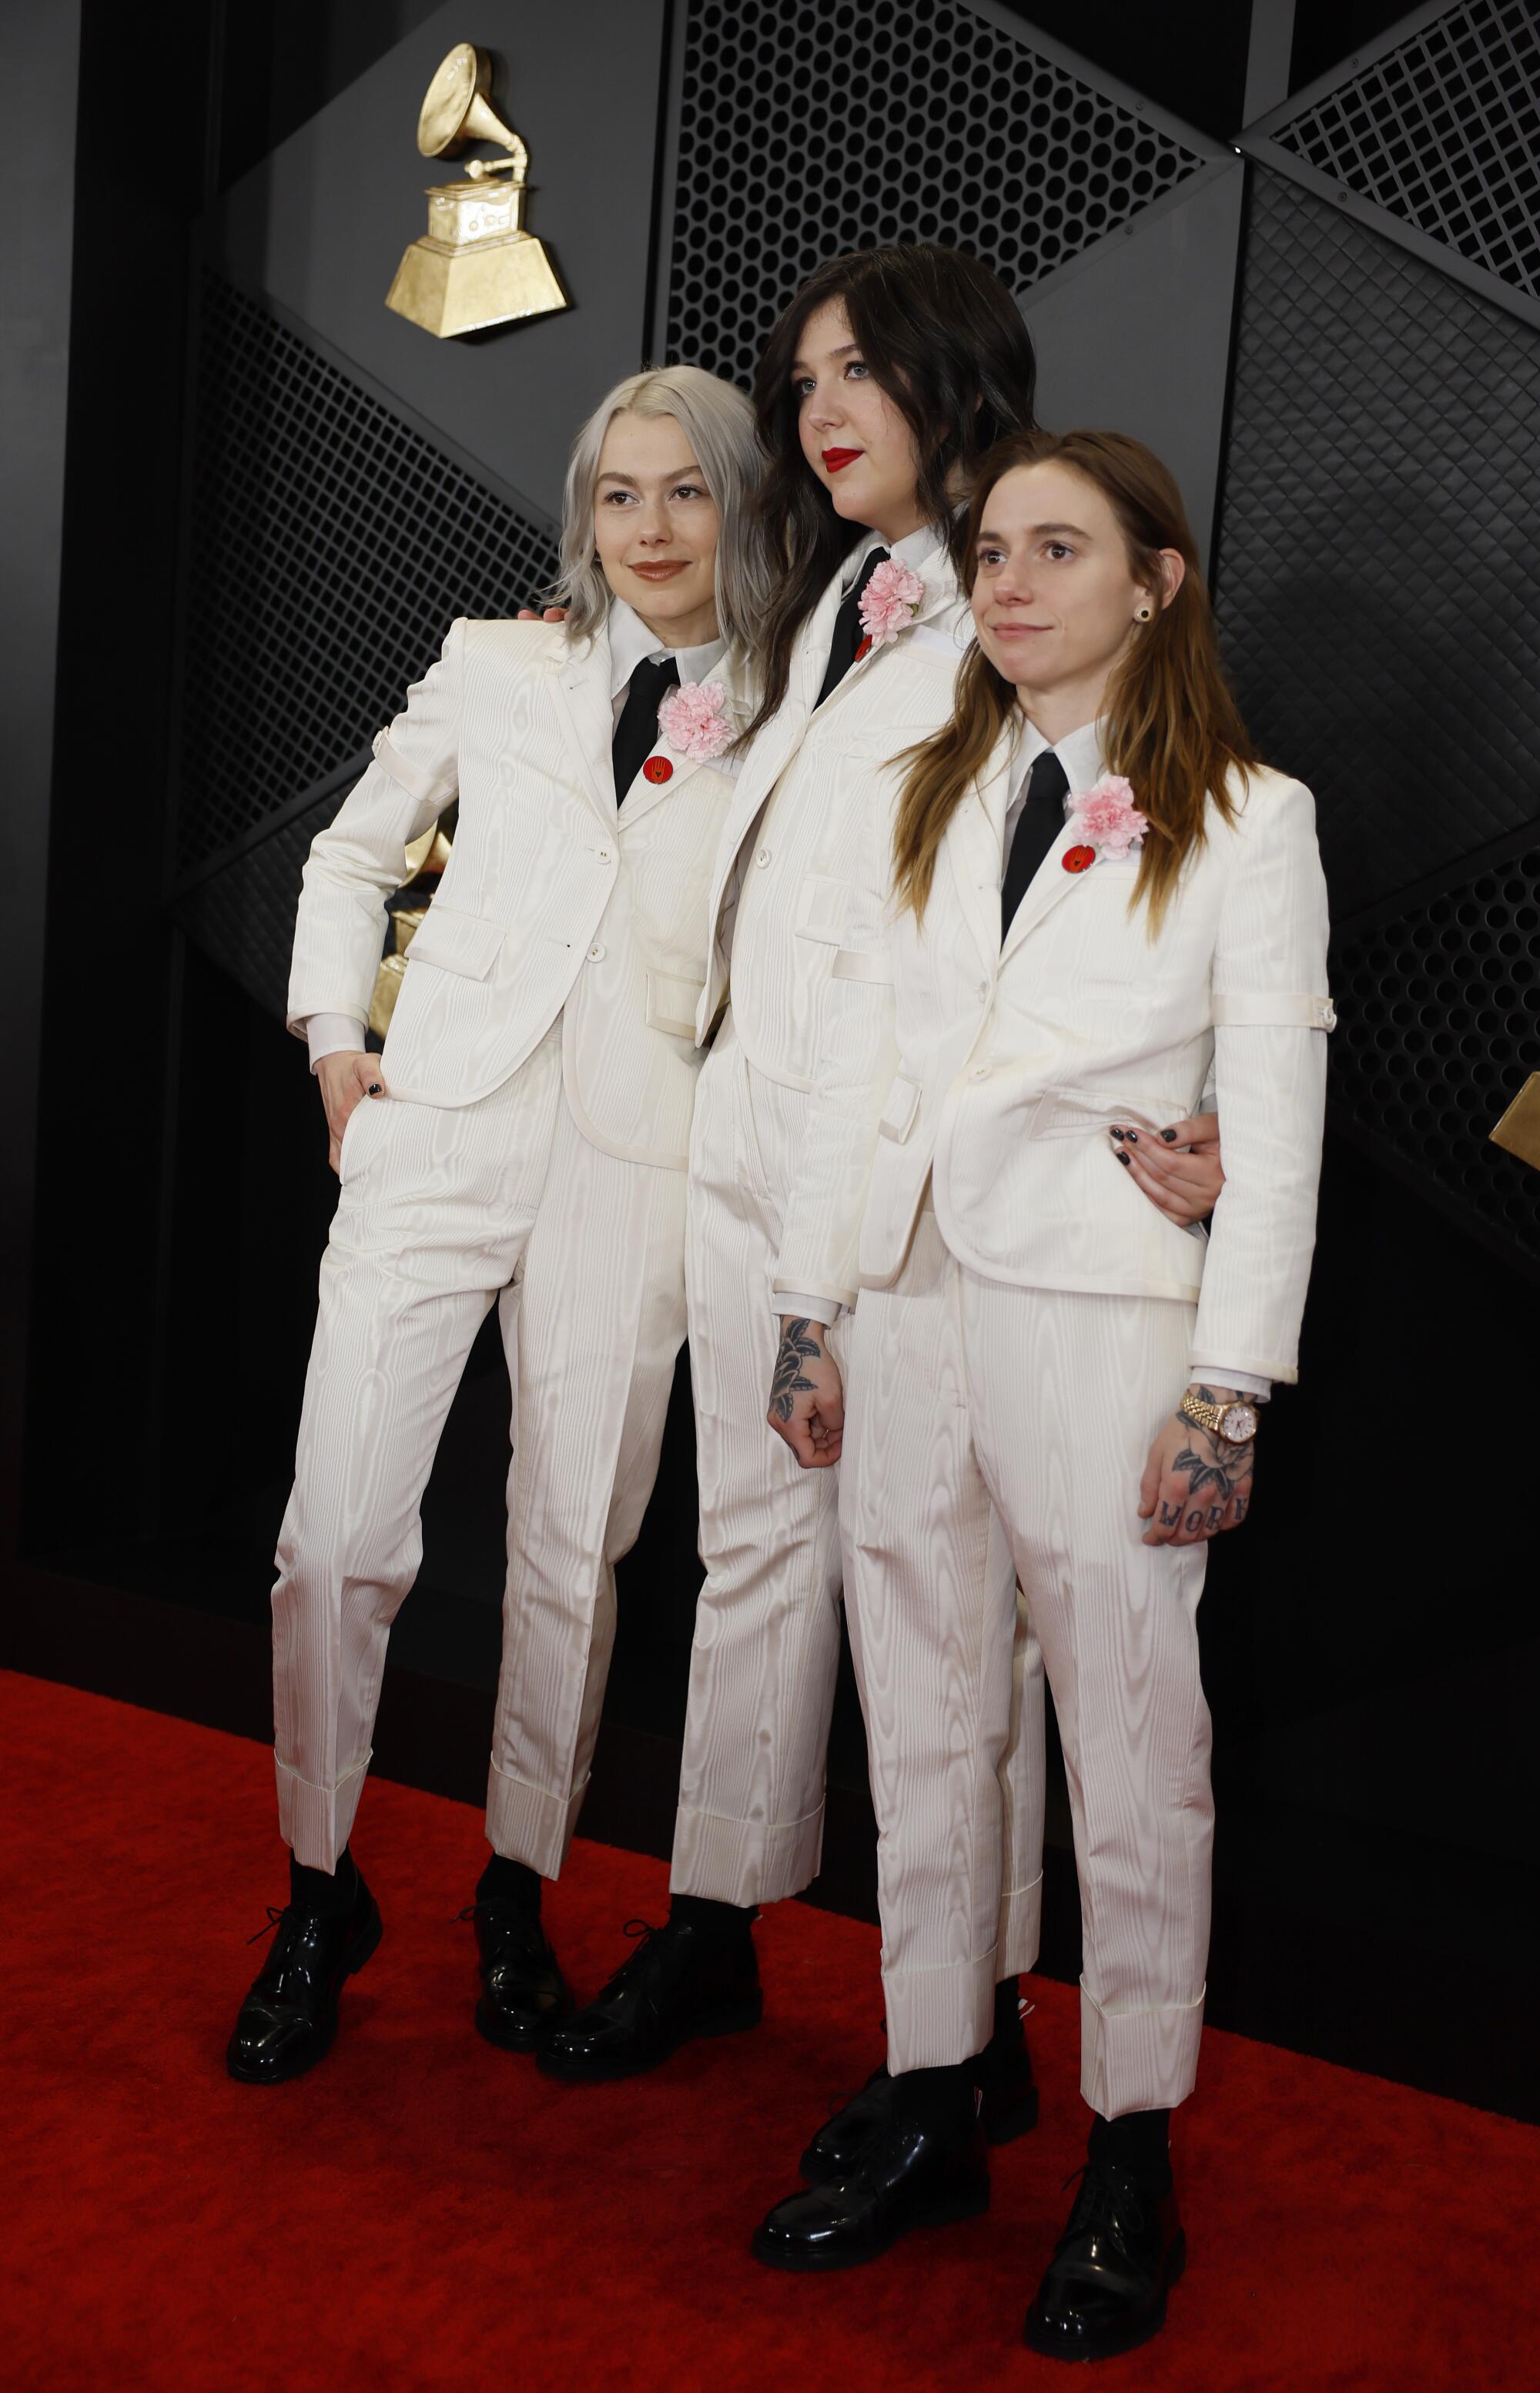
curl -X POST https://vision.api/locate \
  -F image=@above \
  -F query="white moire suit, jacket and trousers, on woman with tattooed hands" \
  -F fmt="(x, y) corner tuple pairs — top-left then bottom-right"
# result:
(808, 722), (1334, 2115)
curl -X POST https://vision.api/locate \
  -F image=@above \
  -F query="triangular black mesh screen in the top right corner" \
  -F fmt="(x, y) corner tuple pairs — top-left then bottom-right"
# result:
(1272, 0), (1540, 296)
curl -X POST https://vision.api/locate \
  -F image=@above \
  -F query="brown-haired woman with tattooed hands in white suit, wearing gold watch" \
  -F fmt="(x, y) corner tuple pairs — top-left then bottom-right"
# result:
(755, 433), (1334, 2357)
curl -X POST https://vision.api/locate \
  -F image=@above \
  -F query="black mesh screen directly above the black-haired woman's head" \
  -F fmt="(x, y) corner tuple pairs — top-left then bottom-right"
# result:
(667, 0), (1205, 383)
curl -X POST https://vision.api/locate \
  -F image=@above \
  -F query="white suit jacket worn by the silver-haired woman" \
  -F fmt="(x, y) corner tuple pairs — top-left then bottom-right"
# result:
(290, 617), (748, 1170)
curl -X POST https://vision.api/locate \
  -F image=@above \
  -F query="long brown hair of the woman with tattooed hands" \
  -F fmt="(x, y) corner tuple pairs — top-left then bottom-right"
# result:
(894, 430), (1260, 938)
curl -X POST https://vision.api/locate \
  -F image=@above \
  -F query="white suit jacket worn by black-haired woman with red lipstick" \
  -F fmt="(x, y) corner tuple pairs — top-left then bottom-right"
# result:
(696, 538), (973, 1304)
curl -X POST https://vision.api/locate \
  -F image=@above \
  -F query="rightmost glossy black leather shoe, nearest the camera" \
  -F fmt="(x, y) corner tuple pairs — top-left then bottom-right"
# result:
(1021, 2161), (1186, 2359)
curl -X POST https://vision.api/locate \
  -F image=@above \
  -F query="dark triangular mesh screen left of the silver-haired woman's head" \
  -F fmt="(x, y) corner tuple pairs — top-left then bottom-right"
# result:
(177, 278), (557, 880)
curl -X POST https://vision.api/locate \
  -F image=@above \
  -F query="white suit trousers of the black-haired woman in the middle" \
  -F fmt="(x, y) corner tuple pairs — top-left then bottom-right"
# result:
(670, 1022), (1043, 1976)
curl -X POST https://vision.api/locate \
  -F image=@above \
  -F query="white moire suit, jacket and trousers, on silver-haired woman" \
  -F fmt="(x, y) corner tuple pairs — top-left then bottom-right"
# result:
(273, 622), (742, 1876)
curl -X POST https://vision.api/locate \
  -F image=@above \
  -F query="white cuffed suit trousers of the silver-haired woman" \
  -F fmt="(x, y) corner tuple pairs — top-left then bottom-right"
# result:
(273, 1022), (684, 1879)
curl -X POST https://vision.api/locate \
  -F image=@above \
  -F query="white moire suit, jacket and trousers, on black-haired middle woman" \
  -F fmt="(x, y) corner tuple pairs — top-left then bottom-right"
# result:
(672, 536), (1043, 1943)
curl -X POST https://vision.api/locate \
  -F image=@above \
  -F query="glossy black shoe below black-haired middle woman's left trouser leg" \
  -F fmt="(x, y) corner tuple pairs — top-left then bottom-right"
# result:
(541, 1919), (763, 2077)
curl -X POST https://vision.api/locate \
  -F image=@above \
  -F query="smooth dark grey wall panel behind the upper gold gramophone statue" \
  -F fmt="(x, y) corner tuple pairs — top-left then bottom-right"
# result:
(210, 0), (665, 514)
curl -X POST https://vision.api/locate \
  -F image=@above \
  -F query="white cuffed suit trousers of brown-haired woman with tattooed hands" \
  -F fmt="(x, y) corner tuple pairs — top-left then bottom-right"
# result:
(842, 1209), (1213, 2118)
